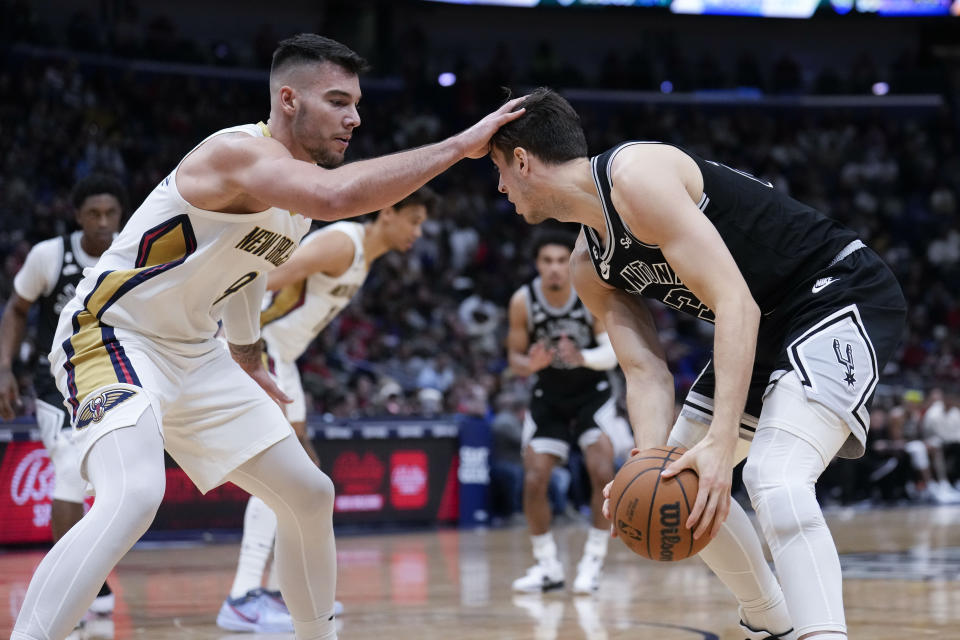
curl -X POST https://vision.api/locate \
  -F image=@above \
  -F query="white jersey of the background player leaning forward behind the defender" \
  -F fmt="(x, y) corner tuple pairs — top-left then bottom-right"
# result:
(260, 221), (367, 362)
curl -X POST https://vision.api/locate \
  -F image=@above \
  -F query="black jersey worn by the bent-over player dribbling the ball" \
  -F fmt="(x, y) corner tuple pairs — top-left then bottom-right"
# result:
(584, 142), (857, 322)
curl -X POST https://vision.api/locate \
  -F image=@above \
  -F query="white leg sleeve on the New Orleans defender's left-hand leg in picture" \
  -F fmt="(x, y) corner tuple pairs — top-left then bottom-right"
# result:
(12, 411), (166, 640)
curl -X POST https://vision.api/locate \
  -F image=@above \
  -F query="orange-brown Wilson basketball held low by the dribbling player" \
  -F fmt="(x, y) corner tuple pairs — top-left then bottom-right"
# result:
(610, 447), (710, 562)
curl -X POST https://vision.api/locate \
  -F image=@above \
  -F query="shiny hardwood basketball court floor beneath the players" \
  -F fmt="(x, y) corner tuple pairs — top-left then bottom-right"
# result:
(0, 507), (960, 640)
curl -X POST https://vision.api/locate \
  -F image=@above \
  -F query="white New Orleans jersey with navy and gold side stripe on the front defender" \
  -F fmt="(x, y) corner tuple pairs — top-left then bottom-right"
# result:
(51, 123), (310, 410)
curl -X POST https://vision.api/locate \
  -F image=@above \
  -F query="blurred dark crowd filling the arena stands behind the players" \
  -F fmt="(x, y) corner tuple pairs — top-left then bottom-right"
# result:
(0, 1), (960, 510)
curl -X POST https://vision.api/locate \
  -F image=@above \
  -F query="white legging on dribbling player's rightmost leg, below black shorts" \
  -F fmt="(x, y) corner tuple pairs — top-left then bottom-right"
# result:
(743, 375), (850, 636)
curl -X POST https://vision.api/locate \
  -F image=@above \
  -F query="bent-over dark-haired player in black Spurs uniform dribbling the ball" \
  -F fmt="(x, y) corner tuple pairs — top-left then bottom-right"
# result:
(491, 89), (906, 640)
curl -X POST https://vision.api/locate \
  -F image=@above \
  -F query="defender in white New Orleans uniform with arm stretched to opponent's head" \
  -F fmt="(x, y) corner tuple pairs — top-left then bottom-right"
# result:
(12, 34), (519, 640)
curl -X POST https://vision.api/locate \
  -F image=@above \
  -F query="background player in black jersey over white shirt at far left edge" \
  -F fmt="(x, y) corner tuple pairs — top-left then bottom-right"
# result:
(0, 174), (127, 614)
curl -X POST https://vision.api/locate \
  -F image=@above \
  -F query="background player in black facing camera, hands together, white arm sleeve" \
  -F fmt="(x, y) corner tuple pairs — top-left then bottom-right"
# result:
(507, 230), (617, 593)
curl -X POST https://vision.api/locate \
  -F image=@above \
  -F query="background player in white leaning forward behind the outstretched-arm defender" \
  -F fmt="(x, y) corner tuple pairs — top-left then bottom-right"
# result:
(217, 187), (436, 631)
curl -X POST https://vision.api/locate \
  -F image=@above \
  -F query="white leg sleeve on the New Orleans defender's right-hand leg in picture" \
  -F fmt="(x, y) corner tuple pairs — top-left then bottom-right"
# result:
(227, 437), (337, 640)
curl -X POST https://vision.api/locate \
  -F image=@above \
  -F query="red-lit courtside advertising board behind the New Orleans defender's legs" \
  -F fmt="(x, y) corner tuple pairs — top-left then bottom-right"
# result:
(0, 420), (461, 544)
